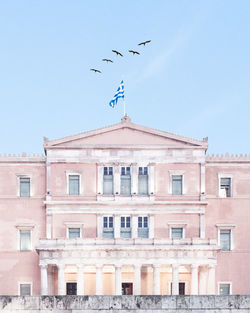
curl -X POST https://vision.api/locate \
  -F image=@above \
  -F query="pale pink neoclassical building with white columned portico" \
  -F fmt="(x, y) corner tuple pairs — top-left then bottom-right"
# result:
(0, 116), (250, 295)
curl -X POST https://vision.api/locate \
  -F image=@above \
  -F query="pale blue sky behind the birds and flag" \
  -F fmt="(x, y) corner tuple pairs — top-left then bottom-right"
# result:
(0, 0), (250, 153)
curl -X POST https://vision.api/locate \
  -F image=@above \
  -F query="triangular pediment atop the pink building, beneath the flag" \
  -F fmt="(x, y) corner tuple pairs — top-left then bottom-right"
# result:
(44, 118), (207, 148)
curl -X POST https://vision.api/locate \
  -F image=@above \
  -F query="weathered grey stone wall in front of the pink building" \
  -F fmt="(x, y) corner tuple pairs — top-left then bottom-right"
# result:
(0, 295), (250, 313)
